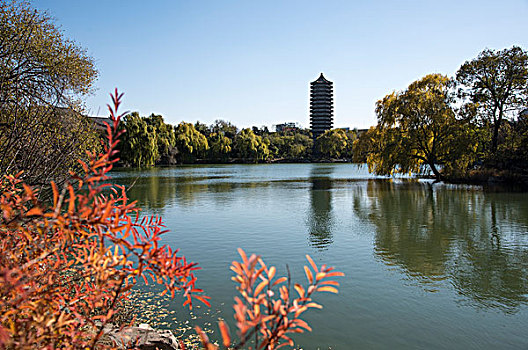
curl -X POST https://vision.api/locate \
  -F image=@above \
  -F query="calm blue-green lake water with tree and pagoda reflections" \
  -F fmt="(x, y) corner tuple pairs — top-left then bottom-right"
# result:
(113, 164), (528, 349)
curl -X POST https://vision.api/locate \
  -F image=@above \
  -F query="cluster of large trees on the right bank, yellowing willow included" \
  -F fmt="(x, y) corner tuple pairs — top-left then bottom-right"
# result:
(353, 46), (528, 180)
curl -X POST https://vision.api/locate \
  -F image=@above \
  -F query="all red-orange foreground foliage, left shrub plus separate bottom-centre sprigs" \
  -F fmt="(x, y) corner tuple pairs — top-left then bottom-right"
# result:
(0, 90), (343, 349)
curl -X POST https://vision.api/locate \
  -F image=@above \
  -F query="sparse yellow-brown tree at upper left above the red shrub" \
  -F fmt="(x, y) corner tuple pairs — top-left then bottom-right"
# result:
(0, 0), (98, 185)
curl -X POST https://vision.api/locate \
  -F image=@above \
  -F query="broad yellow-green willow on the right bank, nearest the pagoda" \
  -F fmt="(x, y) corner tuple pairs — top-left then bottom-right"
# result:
(356, 74), (476, 180)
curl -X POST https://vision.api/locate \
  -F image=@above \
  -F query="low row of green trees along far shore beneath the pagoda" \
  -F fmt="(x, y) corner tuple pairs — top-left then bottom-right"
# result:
(119, 112), (358, 167)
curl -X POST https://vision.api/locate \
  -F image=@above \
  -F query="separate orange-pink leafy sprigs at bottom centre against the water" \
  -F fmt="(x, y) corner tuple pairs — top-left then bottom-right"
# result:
(196, 249), (344, 350)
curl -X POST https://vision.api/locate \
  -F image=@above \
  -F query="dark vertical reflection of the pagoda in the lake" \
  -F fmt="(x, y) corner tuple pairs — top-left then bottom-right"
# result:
(307, 165), (334, 249)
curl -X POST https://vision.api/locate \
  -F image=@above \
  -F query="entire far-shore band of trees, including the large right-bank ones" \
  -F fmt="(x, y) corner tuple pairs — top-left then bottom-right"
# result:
(112, 46), (528, 182)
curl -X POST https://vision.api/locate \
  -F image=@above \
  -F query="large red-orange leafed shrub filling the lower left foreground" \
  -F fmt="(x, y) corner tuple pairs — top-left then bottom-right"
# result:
(0, 90), (207, 349)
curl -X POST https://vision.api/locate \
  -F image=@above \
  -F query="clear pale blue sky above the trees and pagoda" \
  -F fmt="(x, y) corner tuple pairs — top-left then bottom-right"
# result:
(33, 0), (528, 128)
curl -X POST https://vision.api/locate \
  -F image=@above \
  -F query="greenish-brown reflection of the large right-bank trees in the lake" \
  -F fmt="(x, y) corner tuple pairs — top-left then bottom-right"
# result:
(353, 180), (528, 312)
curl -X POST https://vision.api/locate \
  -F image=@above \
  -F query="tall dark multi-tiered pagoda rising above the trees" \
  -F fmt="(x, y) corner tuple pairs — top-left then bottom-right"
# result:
(310, 73), (334, 140)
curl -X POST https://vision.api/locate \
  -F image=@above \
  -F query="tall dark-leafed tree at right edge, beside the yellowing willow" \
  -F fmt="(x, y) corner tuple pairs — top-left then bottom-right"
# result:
(456, 46), (528, 154)
